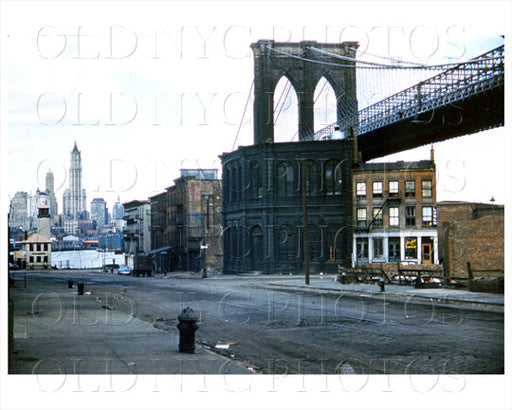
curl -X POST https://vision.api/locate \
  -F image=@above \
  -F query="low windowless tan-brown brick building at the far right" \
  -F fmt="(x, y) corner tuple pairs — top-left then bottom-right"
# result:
(437, 202), (505, 279)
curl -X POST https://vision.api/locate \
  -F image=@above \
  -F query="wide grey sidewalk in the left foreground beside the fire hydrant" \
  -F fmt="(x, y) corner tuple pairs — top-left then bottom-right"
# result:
(9, 279), (252, 375)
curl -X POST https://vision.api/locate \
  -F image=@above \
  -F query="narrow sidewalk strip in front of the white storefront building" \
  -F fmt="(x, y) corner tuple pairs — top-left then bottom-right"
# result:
(266, 276), (505, 313)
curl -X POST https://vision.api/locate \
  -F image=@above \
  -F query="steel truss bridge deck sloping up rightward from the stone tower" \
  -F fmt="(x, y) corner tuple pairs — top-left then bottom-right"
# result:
(312, 46), (505, 159)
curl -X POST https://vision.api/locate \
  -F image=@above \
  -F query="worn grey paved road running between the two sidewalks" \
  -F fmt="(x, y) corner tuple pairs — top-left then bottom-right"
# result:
(9, 271), (504, 374)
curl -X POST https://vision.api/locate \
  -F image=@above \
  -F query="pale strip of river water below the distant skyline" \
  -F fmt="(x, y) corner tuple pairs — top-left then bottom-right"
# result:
(51, 250), (125, 269)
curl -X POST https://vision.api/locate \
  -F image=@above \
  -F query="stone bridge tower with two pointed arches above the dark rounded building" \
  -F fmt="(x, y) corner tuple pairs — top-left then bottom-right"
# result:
(251, 40), (358, 144)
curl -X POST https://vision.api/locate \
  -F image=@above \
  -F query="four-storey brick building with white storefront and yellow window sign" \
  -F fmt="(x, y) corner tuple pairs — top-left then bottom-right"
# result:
(352, 152), (438, 266)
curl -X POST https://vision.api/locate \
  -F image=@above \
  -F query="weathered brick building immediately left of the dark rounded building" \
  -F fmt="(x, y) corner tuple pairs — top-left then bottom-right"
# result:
(149, 169), (222, 272)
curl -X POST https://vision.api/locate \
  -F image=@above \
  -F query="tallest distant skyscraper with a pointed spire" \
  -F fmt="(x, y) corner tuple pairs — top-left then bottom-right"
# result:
(63, 142), (87, 219)
